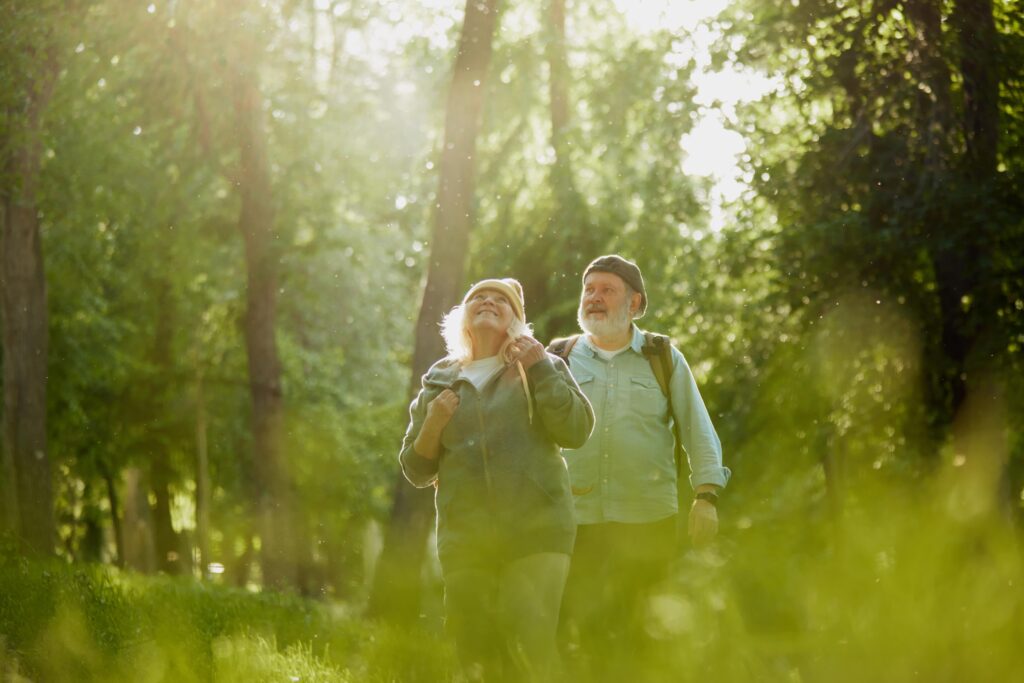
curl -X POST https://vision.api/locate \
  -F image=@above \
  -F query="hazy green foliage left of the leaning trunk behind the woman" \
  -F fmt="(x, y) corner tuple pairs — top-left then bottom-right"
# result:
(23, 2), (442, 594)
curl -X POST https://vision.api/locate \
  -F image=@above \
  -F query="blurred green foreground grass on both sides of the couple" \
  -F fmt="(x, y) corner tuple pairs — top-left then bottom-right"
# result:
(0, 474), (1024, 683)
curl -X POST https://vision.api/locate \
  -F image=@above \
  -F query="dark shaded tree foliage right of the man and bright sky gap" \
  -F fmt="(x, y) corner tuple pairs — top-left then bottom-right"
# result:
(714, 1), (1024, 508)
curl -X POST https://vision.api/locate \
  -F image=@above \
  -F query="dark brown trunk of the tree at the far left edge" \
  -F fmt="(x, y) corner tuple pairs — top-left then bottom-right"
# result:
(0, 42), (58, 555)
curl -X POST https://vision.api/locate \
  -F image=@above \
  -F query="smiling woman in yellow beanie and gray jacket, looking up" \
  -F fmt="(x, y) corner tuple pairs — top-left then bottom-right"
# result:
(400, 279), (594, 678)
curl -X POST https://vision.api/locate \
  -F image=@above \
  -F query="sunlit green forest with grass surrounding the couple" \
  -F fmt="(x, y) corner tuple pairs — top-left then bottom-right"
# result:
(0, 0), (1024, 682)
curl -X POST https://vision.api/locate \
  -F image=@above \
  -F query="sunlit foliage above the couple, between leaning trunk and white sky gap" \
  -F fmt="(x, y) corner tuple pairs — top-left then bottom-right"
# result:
(468, 2), (707, 340)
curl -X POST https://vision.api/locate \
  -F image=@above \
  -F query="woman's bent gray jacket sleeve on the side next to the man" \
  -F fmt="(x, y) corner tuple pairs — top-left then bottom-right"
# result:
(528, 353), (594, 449)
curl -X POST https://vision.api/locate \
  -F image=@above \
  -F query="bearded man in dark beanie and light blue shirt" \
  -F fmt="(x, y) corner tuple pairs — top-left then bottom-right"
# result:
(549, 255), (730, 654)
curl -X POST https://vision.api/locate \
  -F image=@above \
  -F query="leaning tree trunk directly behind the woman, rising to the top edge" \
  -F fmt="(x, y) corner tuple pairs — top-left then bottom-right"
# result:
(370, 0), (507, 621)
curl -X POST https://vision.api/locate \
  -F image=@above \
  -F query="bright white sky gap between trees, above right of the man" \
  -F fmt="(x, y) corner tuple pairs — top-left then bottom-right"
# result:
(614, 0), (774, 231)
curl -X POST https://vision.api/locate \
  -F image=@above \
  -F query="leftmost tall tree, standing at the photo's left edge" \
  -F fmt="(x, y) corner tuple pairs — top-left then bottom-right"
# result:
(0, 2), (68, 554)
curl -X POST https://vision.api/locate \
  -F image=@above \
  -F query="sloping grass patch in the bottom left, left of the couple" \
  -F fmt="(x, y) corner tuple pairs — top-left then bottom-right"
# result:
(0, 555), (452, 681)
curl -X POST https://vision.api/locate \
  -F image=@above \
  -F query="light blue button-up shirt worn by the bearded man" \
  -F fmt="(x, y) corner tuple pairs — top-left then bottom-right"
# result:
(562, 326), (730, 524)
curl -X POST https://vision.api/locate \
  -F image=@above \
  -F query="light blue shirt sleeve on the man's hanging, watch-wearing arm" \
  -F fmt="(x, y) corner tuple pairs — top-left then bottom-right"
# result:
(671, 347), (732, 488)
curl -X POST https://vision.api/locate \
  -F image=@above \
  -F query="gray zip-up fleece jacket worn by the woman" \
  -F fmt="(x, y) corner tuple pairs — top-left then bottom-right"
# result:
(399, 354), (594, 572)
